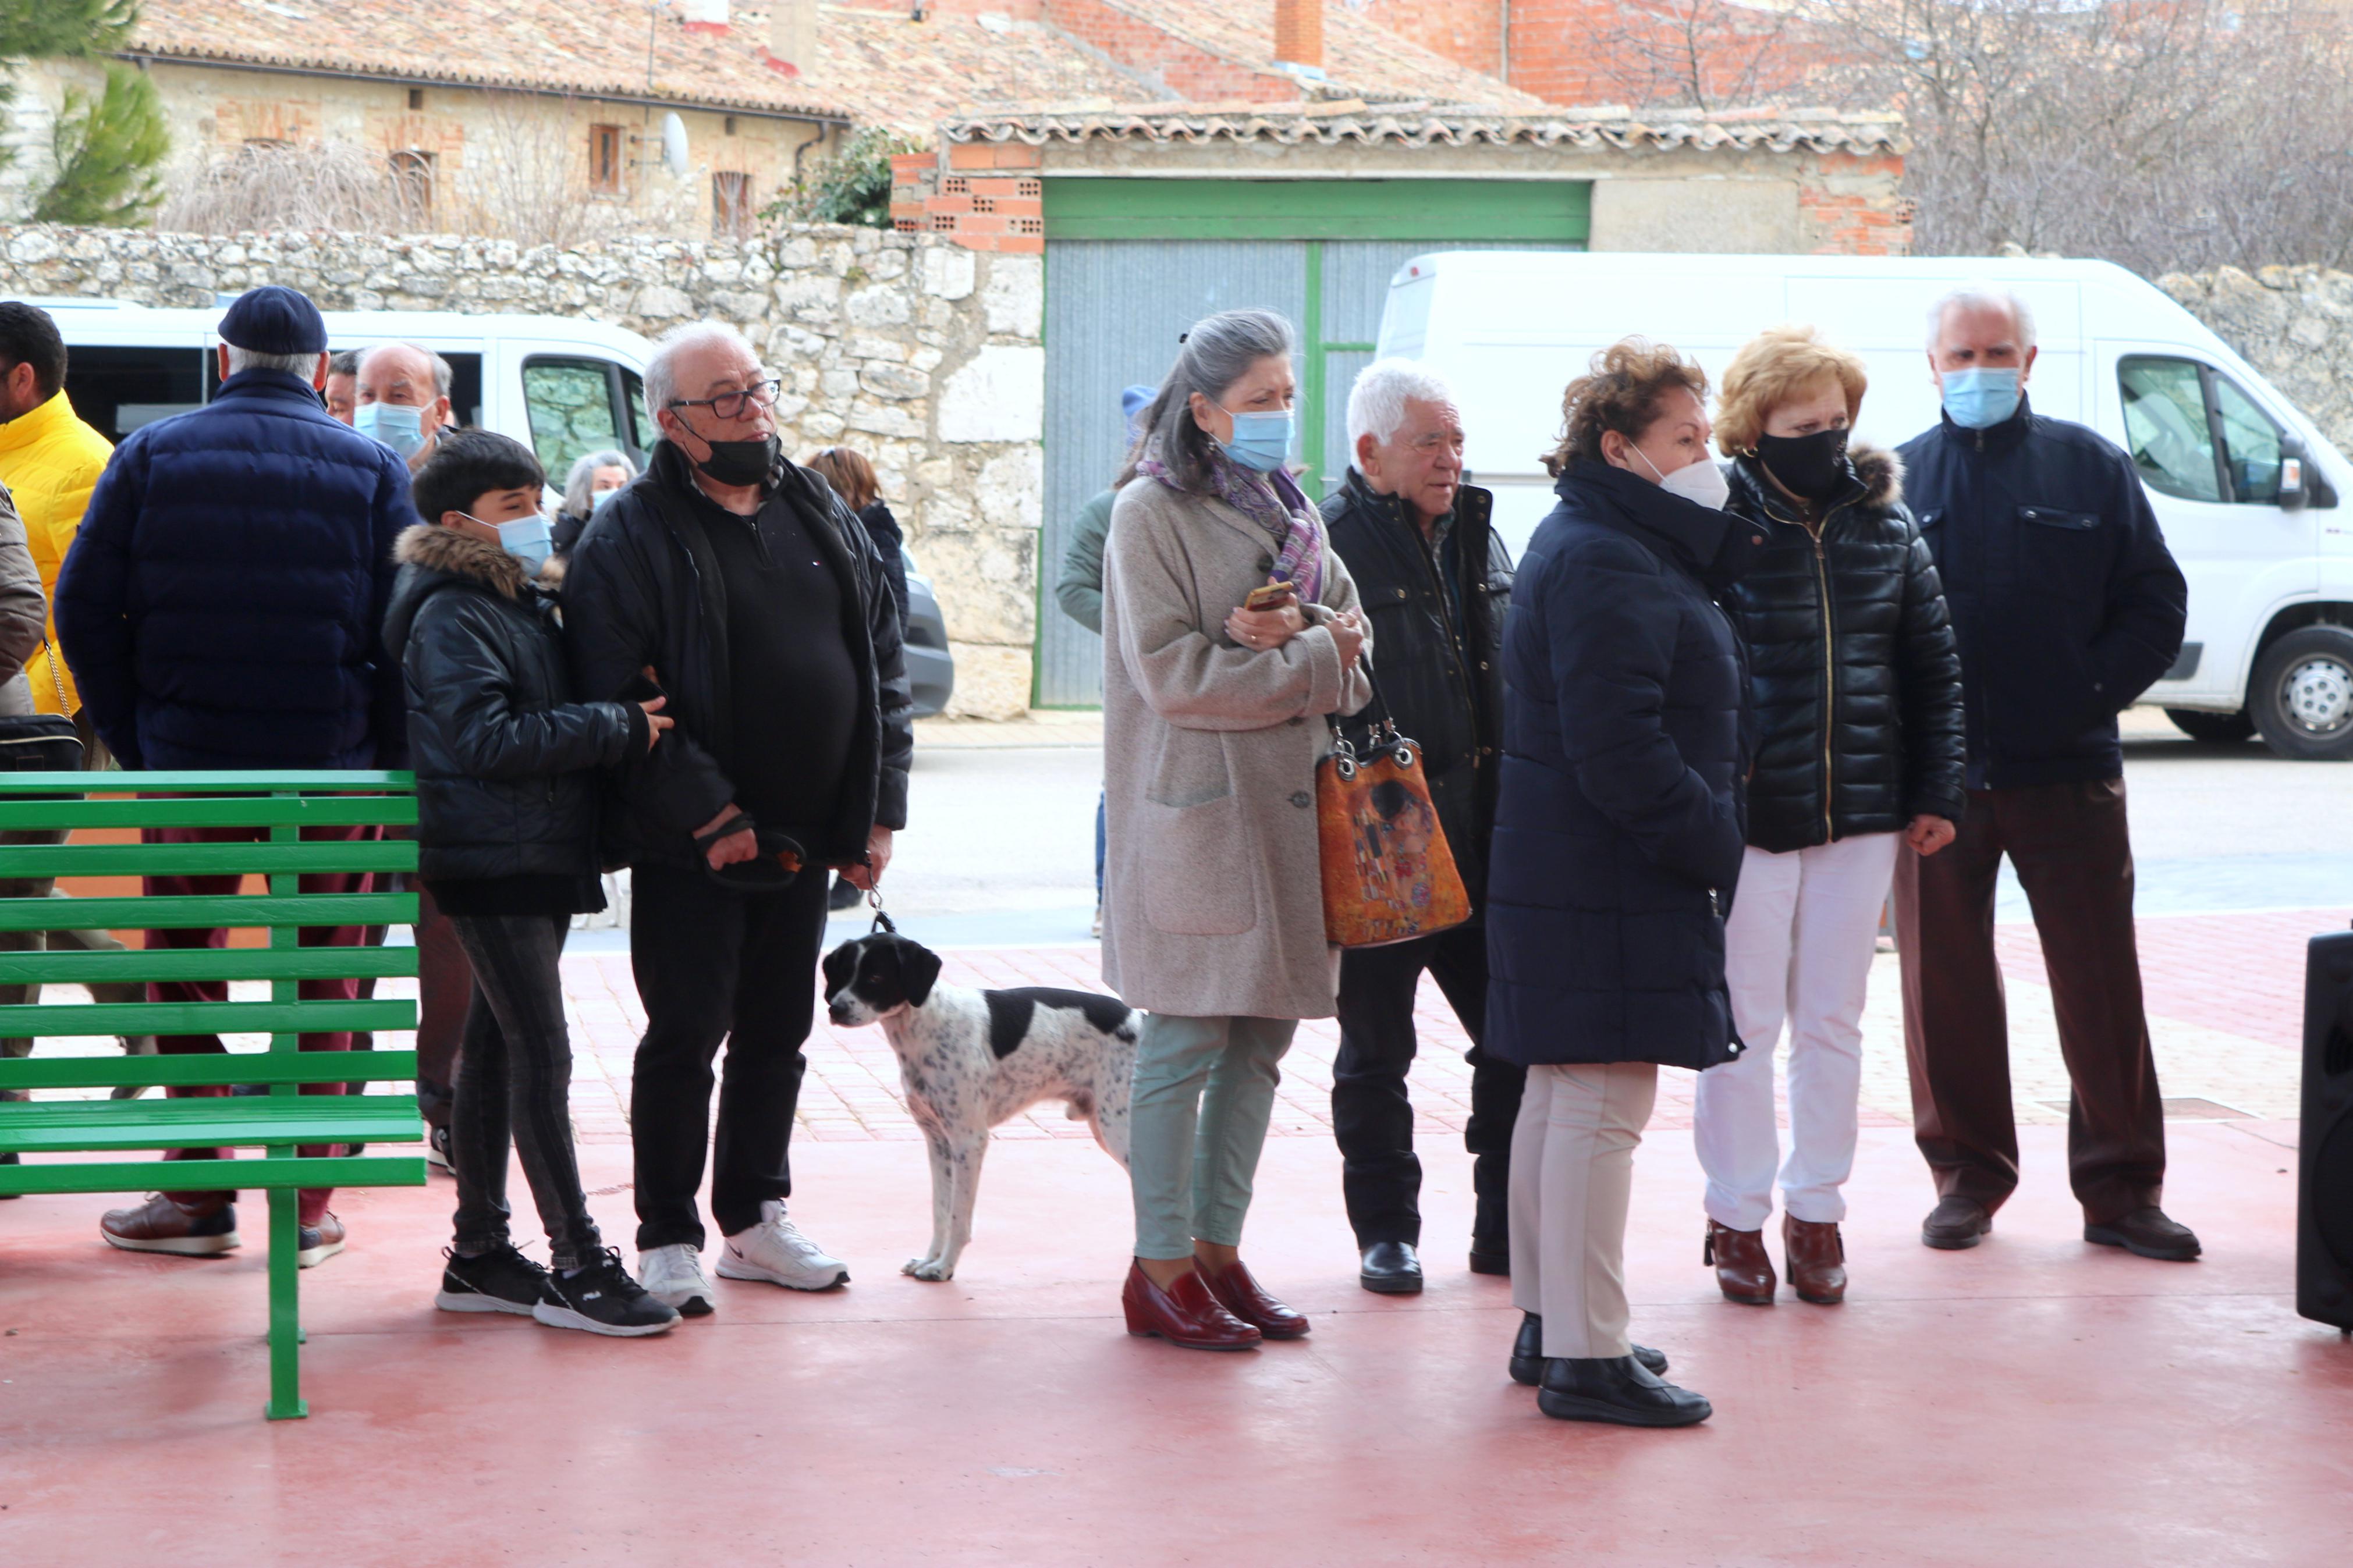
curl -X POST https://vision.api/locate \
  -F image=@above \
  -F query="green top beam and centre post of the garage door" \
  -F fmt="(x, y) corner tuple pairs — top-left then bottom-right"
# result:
(1045, 176), (1593, 503)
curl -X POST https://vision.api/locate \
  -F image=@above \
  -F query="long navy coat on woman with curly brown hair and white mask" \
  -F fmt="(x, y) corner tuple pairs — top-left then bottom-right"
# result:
(1487, 461), (1748, 1067)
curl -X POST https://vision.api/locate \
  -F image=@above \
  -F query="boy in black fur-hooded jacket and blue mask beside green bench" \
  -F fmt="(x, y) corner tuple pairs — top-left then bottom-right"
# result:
(384, 430), (677, 1335)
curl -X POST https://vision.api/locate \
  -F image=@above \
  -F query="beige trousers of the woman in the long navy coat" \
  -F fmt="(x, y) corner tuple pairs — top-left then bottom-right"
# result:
(1511, 1062), (1659, 1359)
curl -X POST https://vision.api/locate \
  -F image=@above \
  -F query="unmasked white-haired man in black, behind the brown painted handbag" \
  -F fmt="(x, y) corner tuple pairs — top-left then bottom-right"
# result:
(1322, 360), (1525, 1295)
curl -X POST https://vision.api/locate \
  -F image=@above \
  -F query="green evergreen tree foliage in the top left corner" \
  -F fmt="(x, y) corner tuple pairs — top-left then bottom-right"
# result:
(0, 0), (172, 223)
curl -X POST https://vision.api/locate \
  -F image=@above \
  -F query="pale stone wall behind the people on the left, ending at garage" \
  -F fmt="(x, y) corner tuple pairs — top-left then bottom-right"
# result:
(0, 223), (1045, 717)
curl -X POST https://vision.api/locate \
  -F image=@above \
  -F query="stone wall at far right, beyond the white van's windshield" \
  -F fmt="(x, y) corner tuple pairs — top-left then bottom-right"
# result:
(2157, 266), (2353, 454)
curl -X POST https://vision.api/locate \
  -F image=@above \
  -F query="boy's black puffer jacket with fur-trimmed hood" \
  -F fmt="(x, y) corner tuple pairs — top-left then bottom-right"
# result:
(384, 527), (647, 881)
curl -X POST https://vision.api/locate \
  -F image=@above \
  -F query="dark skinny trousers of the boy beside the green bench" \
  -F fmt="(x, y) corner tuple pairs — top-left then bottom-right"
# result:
(442, 915), (602, 1270)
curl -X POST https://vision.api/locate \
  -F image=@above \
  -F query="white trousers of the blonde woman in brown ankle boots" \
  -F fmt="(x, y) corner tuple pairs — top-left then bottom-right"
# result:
(1692, 832), (1901, 1229)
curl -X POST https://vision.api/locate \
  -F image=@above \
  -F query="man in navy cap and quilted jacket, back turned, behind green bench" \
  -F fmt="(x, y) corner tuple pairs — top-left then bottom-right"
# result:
(56, 285), (417, 1267)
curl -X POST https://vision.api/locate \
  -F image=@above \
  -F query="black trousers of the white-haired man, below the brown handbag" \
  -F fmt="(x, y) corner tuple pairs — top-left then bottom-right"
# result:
(1332, 922), (1527, 1253)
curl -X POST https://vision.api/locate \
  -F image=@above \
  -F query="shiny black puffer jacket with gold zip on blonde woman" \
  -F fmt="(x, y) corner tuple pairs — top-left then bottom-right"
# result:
(1725, 447), (1967, 854)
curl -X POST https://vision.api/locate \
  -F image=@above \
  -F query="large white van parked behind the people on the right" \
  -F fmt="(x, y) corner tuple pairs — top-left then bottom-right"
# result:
(1379, 251), (2353, 759)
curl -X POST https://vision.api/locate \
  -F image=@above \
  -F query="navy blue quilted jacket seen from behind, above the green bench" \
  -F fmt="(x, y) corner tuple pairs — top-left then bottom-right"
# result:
(56, 369), (417, 769)
